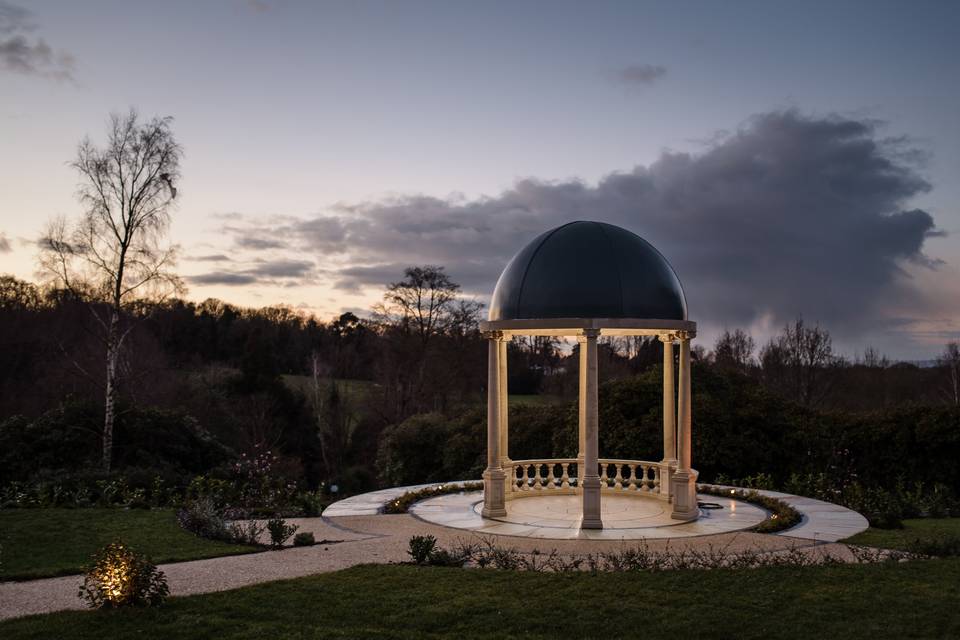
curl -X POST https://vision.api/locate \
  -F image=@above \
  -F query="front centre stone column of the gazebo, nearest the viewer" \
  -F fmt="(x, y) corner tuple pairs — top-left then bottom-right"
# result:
(577, 329), (603, 529)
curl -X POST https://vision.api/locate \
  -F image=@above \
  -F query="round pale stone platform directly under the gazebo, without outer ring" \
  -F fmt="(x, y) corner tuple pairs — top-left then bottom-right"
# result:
(410, 491), (767, 540)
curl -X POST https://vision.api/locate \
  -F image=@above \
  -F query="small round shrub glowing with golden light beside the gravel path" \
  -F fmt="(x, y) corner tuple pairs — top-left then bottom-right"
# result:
(77, 541), (170, 609)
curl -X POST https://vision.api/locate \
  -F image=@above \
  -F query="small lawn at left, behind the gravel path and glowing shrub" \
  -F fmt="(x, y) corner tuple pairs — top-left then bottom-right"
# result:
(0, 509), (259, 580)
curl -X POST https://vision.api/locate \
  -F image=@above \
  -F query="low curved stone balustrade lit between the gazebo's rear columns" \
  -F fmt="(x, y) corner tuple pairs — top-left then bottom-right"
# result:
(503, 458), (672, 500)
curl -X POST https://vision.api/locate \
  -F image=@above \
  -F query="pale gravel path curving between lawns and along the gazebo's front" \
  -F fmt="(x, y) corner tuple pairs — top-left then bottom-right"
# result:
(0, 514), (849, 619)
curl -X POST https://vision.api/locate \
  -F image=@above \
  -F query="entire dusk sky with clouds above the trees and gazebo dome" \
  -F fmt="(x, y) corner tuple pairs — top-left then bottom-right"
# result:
(0, 0), (960, 360)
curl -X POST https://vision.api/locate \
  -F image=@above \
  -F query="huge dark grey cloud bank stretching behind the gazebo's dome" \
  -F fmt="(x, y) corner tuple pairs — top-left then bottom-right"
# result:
(216, 111), (938, 340)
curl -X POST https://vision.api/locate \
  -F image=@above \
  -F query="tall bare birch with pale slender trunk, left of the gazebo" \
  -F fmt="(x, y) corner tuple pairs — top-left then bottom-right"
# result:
(40, 109), (183, 471)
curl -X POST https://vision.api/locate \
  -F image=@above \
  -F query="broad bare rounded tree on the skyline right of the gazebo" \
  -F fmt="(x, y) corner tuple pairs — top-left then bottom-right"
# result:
(760, 318), (843, 407)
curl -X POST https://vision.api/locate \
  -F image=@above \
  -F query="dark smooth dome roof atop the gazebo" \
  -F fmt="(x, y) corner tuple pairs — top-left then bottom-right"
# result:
(490, 222), (687, 320)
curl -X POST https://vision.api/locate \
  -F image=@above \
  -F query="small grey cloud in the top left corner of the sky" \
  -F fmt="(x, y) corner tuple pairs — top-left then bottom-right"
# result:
(0, 0), (75, 81)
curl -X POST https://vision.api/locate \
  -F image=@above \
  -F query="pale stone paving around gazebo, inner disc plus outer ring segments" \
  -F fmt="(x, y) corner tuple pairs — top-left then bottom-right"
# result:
(323, 482), (868, 542)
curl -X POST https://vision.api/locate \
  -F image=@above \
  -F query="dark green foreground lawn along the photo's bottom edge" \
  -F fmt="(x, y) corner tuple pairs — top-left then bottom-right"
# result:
(0, 558), (960, 640)
